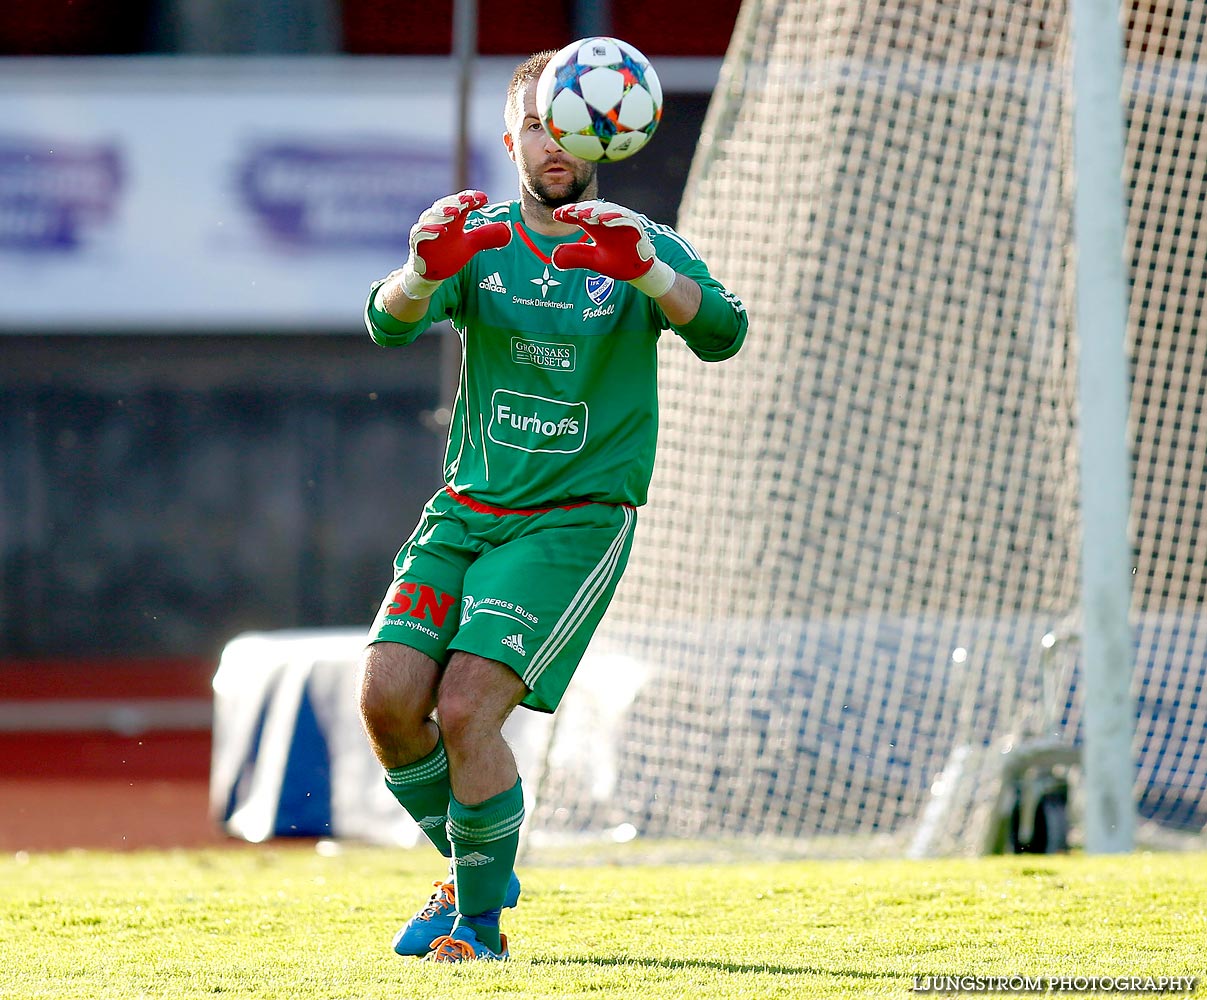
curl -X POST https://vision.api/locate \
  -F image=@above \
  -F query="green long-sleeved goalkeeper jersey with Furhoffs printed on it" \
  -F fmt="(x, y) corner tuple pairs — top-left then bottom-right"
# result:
(365, 201), (746, 509)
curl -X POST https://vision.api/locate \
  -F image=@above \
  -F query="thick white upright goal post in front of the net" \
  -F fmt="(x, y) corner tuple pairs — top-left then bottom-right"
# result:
(1072, 0), (1136, 853)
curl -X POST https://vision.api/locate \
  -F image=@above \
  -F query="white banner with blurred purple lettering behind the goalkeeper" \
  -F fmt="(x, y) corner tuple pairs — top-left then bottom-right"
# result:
(0, 58), (517, 333)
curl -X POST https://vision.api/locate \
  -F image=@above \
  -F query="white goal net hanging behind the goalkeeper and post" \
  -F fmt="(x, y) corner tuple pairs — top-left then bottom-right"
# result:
(533, 0), (1207, 854)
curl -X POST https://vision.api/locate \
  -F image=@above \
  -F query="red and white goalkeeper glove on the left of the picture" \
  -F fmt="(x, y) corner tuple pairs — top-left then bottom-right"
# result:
(400, 191), (512, 299)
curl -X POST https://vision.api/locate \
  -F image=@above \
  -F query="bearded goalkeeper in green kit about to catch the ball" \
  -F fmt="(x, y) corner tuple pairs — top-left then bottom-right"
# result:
(360, 52), (746, 961)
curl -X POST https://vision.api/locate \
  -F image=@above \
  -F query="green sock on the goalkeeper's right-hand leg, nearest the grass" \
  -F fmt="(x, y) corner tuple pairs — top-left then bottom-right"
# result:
(448, 778), (524, 952)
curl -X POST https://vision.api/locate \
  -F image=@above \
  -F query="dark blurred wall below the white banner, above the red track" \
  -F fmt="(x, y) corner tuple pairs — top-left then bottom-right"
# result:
(0, 334), (443, 657)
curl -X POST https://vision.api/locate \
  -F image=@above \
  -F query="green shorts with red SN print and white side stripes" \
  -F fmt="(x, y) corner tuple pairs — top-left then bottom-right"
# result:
(369, 490), (637, 712)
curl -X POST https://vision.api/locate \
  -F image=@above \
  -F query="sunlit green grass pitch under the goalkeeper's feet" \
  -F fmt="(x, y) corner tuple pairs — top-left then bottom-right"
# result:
(0, 846), (1207, 1000)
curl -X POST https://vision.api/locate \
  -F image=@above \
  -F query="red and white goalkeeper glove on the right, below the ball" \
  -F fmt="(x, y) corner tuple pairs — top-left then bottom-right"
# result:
(553, 201), (676, 299)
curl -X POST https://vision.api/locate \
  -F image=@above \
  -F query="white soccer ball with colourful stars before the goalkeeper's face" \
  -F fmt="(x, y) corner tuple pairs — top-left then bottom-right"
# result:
(536, 36), (663, 160)
